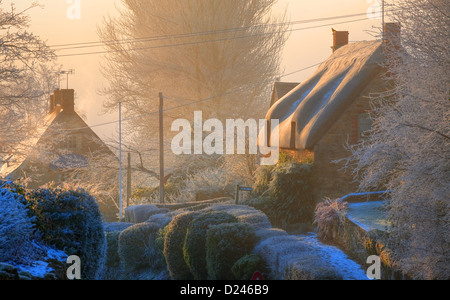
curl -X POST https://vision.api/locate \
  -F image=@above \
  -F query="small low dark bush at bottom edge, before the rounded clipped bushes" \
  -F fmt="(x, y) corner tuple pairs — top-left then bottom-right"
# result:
(231, 254), (270, 280)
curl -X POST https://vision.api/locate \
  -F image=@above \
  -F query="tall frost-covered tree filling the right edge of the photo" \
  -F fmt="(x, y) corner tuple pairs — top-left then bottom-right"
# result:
(346, 0), (450, 279)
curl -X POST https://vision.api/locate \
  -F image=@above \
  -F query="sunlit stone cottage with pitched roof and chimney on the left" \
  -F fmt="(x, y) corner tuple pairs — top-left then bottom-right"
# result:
(0, 89), (118, 220)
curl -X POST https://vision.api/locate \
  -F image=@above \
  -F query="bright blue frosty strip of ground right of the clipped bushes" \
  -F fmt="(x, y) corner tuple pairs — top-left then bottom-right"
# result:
(296, 233), (368, 280)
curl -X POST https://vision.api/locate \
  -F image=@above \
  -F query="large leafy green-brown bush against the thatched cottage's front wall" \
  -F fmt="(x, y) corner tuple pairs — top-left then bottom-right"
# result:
(247, 163), (316, 228)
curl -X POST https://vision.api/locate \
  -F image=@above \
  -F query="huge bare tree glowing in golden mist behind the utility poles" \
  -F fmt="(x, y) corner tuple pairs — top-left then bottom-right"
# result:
(99, 0), (287, 135)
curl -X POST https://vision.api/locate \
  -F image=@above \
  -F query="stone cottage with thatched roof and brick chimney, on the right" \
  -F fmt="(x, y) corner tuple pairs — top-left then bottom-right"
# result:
(266, 24), (399, 201)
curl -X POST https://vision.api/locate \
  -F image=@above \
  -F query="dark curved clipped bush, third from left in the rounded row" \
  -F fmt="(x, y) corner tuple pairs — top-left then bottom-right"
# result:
(183, 212), (238, 280)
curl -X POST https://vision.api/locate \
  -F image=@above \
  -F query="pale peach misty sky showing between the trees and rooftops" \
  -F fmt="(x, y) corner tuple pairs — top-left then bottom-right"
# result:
(7, 0), (381, 137)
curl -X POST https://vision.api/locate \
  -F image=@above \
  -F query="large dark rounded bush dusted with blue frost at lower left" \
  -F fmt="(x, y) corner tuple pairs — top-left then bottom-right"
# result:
(26, 188), (106, 279)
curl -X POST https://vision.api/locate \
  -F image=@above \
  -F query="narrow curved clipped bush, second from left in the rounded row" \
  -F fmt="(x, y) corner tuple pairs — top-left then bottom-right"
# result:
(164, 212), (199, 280)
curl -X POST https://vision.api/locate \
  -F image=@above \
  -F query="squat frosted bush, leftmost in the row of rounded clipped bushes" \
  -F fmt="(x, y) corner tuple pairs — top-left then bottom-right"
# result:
(119, 223), (162, 273)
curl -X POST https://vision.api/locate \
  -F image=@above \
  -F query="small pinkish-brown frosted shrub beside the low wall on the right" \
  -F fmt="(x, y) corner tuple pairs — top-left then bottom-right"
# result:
(314, 199), (348, 241)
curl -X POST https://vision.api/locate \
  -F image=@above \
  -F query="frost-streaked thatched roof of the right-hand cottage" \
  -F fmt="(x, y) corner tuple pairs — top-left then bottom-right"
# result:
(266, 41), (383, 150)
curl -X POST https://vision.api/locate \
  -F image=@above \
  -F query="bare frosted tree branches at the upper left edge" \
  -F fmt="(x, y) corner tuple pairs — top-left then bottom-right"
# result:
(0, 0), (56, 158)
